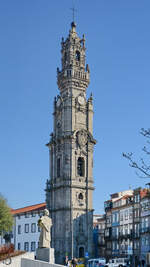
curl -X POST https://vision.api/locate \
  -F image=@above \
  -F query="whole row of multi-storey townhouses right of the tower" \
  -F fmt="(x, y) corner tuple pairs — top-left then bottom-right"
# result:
(93, 188), (150, 266)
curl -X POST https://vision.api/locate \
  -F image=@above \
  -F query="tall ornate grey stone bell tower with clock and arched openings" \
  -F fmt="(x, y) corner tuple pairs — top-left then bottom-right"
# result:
(46, 22), (96, 263)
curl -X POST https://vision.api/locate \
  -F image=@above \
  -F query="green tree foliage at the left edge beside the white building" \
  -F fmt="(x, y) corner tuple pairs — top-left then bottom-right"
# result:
(0, 195), (13, 235)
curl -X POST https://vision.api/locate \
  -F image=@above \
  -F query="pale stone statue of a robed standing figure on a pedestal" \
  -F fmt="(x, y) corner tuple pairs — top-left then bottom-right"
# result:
(38, 209), (52, 248)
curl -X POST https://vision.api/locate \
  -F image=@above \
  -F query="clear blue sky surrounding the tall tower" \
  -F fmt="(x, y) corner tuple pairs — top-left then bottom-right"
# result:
(0, 0), (150, 213)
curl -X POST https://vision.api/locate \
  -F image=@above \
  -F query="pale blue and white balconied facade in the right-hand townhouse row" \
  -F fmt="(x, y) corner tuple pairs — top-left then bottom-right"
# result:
(104, 190), (133, 259)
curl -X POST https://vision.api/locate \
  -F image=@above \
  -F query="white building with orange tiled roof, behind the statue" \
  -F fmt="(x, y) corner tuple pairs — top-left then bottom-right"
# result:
(11, 203), (46, 252)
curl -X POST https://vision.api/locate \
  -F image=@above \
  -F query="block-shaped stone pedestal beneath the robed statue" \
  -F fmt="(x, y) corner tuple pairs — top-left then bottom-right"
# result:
(36, 248), (55, 264)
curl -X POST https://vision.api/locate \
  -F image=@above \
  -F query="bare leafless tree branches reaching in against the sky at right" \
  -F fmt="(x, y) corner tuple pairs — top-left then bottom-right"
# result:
(123, 128), (150, 178)
